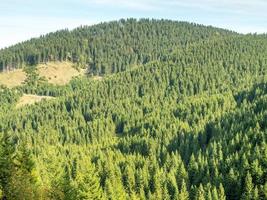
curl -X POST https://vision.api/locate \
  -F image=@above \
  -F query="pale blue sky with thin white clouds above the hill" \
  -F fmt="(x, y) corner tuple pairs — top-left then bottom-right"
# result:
(0, 0), (267, 48)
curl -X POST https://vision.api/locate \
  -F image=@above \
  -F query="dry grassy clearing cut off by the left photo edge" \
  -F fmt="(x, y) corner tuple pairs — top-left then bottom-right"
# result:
(0, 69), (26, 88)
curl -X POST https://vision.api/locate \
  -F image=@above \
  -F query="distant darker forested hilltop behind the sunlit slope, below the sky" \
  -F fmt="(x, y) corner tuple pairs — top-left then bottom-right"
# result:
(0, 19), (237, 74)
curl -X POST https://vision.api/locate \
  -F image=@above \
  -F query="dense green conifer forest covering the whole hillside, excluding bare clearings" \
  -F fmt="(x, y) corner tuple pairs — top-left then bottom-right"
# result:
(0, 19), (267, 200)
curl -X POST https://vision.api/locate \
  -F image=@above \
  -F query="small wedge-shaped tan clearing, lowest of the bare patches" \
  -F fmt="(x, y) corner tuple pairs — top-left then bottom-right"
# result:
(16, 94), (55, 108)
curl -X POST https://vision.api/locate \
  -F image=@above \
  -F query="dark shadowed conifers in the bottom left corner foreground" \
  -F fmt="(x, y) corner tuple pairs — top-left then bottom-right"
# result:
(0, 134), (38, 200)
